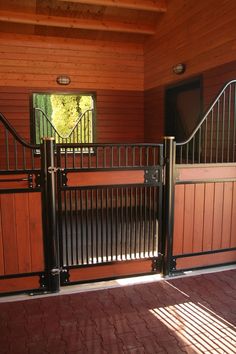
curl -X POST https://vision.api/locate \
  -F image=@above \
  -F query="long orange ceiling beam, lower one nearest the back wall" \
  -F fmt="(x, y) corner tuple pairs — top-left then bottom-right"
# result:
(0, 11), (155, 35)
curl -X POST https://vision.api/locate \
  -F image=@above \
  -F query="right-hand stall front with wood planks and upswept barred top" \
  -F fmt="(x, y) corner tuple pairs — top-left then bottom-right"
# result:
(171, 80), (236, 273)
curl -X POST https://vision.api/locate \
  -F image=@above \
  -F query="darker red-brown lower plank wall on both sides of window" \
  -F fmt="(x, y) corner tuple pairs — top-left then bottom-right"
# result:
(0, 86), (144, 143)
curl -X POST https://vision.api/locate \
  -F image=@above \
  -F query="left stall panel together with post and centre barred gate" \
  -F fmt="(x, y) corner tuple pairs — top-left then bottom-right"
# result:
(0, 115), (164, 293)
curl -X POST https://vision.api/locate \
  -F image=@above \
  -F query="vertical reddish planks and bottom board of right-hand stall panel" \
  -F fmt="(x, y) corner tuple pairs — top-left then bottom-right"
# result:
(173, 181), (236, 269)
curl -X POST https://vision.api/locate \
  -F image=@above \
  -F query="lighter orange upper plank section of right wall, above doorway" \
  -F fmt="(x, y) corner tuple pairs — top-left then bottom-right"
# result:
(144, 0), (236, 90)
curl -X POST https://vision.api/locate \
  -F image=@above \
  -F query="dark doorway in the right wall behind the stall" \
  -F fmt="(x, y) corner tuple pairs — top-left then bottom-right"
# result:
(165, 78), (202, 142)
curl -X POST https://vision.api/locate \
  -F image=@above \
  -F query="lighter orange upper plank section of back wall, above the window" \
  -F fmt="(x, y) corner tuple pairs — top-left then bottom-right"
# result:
(0, 33), (144, 91)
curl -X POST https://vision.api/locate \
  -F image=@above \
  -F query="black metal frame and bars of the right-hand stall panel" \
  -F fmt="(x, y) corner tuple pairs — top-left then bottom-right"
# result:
(166, 80), (236, 274)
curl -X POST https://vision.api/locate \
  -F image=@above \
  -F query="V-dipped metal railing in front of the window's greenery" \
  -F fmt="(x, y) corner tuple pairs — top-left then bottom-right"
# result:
(33, 108), (94, 144)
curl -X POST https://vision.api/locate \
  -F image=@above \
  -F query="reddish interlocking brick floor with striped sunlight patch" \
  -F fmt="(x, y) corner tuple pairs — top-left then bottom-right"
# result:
(0, 270), (236, 354)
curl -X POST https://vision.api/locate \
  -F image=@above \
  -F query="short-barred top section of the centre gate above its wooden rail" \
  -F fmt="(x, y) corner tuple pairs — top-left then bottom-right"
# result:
(56, 143), (163, 169)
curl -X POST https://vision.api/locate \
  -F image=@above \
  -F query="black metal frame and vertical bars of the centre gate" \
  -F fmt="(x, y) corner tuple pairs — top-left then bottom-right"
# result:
(56, 144), (164, 285)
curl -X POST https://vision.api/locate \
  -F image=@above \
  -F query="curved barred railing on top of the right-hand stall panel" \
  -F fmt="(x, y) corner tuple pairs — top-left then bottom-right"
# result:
(176, 80), (236, 164)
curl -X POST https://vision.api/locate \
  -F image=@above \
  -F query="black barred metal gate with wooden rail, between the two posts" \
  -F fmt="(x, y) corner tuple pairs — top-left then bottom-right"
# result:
(56, 144), (163, 283)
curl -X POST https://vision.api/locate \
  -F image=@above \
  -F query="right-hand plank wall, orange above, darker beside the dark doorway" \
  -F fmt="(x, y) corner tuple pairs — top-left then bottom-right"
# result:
(144, 0), (236, 142)
